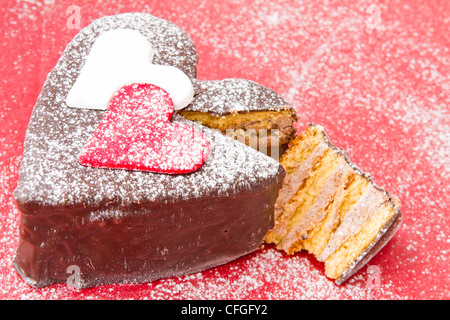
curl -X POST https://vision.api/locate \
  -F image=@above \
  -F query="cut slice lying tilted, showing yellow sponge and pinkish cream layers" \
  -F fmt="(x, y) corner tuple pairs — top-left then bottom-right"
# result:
(265, 124), (402, 284)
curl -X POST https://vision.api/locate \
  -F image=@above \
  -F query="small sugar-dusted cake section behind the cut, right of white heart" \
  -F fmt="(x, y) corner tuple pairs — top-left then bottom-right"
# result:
(179, 78), (297, 160)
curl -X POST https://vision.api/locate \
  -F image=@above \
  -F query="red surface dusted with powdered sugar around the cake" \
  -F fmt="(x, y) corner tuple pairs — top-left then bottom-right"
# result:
(0, 0), (450, 299)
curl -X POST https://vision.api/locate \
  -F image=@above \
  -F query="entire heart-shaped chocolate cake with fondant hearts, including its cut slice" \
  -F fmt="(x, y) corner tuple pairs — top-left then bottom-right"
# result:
(14, 13), (402, 288)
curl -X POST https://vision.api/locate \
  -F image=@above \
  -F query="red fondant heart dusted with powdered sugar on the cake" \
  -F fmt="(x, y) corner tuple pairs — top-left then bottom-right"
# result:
(79, 84), (209, 174)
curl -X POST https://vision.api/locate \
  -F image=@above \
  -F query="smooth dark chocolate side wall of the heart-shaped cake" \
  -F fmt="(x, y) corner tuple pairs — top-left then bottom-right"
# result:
(14, 178), (278, 288)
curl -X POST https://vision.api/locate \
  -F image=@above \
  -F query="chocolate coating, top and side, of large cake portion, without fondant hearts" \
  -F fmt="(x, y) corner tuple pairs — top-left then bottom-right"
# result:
(14, 13), (285, 288)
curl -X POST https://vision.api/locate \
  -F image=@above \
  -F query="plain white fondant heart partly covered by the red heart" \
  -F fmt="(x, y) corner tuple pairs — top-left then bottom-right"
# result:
(66, 29), (194, 110)
